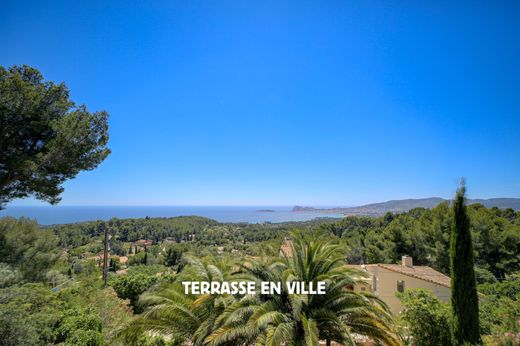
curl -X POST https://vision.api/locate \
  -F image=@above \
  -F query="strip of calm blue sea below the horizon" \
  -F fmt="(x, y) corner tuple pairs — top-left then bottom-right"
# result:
(0, 206), (343, 225)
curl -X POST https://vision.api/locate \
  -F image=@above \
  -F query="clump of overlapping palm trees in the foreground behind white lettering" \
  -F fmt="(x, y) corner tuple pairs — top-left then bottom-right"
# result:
(120, 234), (400, 346)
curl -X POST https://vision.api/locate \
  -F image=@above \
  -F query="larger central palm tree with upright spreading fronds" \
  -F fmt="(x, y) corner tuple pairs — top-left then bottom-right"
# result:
(206, 233), (401, 346)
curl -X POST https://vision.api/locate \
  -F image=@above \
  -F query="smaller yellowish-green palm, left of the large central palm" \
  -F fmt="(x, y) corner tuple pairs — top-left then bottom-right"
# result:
(114, 255), (239, 346)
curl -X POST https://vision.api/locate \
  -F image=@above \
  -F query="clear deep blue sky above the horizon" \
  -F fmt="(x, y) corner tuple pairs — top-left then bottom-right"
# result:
(0, 0), (520, 205)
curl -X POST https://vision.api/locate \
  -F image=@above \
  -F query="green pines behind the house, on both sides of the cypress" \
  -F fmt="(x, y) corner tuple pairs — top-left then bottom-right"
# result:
(320, 202), (520, 283)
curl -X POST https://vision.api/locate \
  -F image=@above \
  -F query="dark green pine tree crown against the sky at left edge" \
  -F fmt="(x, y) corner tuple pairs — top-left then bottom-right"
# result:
(0, 65), (110, 209)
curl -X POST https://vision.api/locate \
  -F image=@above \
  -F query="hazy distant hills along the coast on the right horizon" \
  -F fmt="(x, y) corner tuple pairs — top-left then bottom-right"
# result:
(293, 197), (520, 216)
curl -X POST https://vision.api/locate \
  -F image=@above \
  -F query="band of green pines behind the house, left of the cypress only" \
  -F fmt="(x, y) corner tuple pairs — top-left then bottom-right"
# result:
(330, 203), (451, 273)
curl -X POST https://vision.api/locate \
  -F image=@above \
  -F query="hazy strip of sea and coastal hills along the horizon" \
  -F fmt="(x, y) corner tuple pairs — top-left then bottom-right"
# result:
(0, 197), (520, 225)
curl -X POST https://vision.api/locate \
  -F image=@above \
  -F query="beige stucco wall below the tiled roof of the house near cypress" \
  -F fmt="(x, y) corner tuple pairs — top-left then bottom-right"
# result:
(367, 266), (451, 314)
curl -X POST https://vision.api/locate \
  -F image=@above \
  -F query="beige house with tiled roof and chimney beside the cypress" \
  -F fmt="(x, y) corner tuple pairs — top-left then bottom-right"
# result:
(349, 256), (451, 314)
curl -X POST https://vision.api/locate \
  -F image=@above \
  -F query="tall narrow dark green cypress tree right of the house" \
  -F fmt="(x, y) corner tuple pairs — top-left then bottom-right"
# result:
(450, 180), (481, 345)
